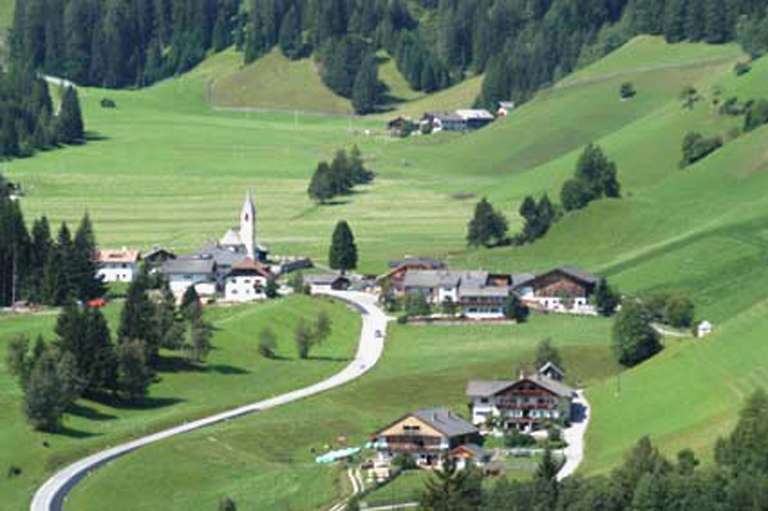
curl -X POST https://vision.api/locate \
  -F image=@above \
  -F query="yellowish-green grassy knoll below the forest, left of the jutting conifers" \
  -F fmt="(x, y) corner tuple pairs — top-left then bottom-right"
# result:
(209, 49), (352, 114)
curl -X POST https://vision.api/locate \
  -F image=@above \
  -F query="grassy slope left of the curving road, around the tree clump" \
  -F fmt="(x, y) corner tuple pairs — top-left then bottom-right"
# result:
(0, 297), (360, 511)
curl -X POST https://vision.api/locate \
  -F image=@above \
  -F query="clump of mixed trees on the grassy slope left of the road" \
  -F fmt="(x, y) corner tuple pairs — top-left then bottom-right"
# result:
(6, 271), (212, 431)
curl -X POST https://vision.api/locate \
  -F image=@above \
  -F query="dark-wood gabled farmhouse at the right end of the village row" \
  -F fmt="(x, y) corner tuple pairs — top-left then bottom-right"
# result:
(515, 266), (598, 314)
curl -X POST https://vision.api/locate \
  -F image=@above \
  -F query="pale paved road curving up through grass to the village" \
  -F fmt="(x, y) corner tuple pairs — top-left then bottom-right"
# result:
(30, 291), (387, 511)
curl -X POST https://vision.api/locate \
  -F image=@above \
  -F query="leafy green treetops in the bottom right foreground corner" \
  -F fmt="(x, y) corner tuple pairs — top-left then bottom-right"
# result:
(419, 390), (768, 511)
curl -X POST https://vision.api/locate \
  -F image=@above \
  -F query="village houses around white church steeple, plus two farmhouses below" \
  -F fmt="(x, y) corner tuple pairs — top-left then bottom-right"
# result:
(76, 192), (612, 494)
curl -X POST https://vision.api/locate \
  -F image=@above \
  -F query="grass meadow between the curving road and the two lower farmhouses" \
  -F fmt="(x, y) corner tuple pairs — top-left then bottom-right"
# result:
(67, 316), (616, 511)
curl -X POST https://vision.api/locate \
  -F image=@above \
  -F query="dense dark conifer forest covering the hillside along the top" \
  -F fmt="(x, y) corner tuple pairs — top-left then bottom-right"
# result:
(11, 0), (768, 114)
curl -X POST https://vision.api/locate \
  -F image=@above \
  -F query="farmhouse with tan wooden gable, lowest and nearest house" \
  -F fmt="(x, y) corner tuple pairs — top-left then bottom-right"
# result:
(374, 408), (478, 466)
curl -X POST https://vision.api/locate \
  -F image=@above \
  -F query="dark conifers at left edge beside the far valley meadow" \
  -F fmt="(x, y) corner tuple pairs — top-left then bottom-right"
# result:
(0, 68), (85, 160)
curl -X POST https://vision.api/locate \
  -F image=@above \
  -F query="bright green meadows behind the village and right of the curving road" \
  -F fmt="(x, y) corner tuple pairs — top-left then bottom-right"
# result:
(0, 37), (768, 511)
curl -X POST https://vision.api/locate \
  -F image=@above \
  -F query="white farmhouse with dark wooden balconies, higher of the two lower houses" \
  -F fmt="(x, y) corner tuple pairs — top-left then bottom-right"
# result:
(467, 366), (574, 432)
